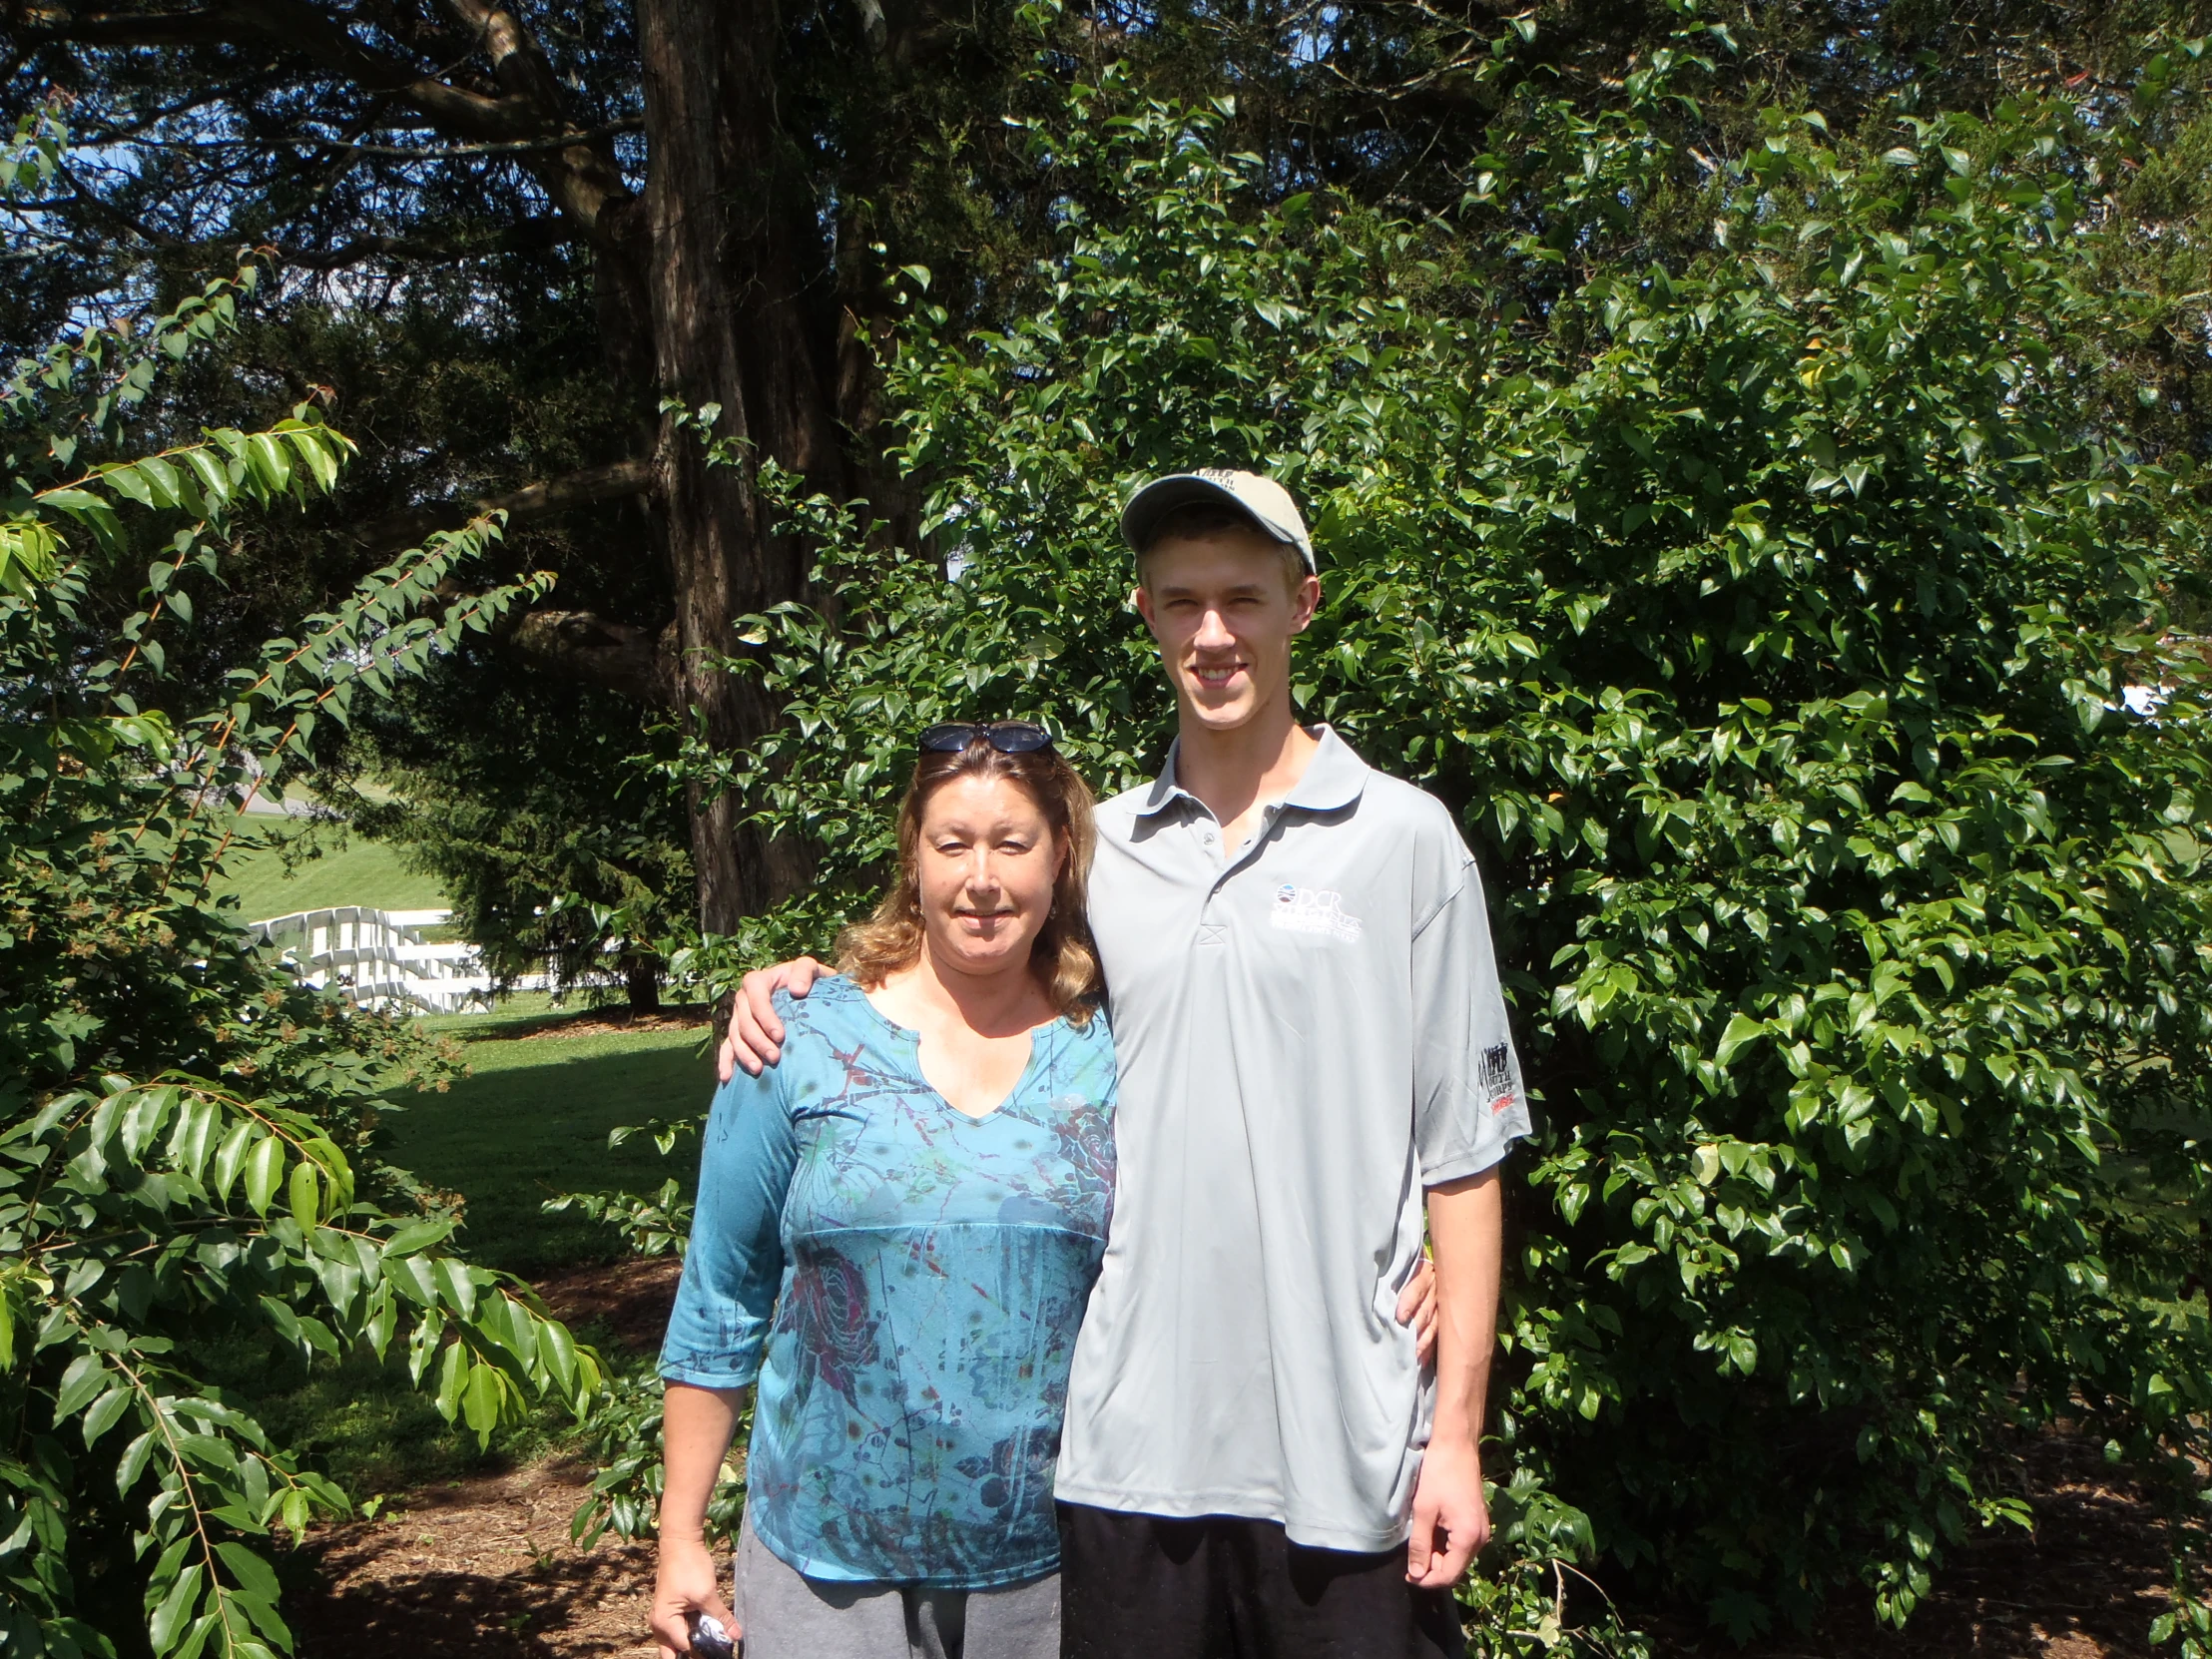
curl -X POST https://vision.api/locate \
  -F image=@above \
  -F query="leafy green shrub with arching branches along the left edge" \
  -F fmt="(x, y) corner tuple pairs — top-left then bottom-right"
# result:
(0, 110), (600, 1659)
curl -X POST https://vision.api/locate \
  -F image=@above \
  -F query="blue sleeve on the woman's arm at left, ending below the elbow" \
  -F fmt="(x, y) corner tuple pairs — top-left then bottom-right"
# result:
(662, 1066), (799, 1389)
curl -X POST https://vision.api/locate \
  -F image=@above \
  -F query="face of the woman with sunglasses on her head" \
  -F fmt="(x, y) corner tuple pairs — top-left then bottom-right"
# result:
(915, 777), (1066, 973)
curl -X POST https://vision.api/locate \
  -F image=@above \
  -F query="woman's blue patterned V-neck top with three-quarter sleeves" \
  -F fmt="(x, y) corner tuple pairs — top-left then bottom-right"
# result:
(662, 977), (1115, 1590)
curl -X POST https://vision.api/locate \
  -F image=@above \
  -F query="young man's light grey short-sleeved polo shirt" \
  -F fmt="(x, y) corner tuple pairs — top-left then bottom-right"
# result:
(1057, 728), (1528, 1550)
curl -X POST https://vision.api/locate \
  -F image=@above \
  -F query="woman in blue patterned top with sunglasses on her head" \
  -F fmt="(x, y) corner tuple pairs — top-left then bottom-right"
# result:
(653, 721), (1429, 1659)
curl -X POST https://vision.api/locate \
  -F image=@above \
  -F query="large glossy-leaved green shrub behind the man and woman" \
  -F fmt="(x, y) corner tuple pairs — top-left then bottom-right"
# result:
(650, 38), (2212, 1650)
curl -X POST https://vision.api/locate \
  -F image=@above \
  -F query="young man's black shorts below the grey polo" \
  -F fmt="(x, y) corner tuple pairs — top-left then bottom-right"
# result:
(1059, 1504), (1466, 1659)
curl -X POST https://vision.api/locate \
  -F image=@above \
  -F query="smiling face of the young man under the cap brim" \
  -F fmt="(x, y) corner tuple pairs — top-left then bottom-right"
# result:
(1133, 529), (1321, 730)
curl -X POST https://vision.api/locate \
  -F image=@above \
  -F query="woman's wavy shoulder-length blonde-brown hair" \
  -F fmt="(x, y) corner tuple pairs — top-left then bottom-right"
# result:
(836, 735), (1099, 1024)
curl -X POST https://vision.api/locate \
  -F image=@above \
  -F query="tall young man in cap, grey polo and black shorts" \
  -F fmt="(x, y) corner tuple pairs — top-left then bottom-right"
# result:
(724, 471), (1528, 1659)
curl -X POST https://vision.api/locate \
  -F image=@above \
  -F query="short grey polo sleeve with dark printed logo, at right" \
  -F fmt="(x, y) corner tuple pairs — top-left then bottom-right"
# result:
(1413, 853), (1528, 1186)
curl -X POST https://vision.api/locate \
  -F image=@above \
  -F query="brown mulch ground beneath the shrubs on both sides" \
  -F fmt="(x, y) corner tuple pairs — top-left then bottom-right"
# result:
(285, 1261), (2165, 1659)
